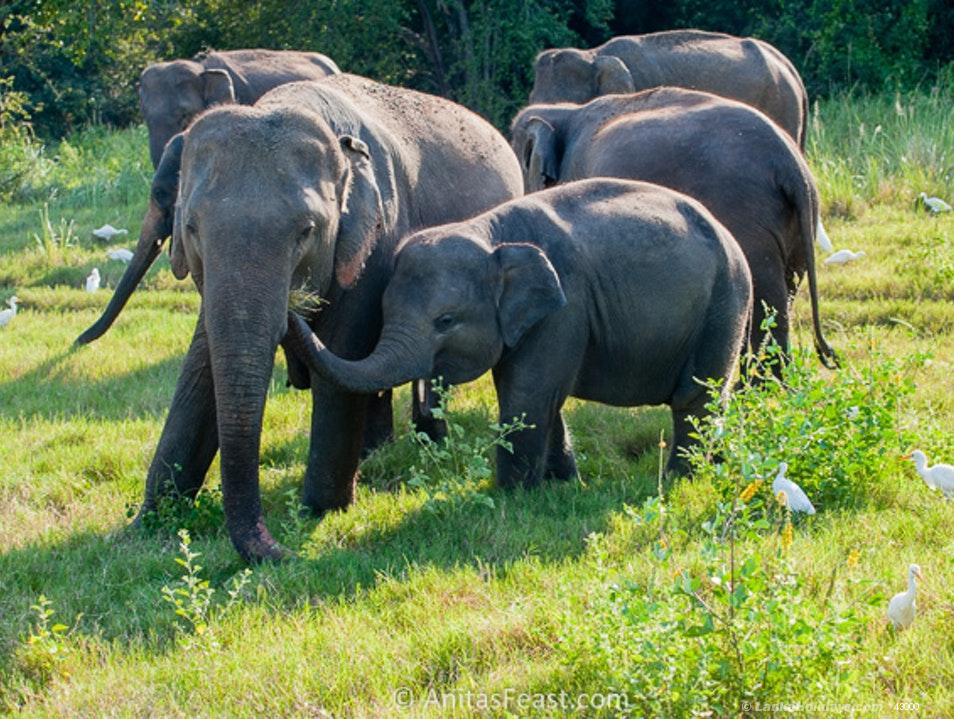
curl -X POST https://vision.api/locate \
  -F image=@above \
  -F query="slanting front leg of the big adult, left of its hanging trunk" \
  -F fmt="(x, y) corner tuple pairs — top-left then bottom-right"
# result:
(137, 312), (219, 521)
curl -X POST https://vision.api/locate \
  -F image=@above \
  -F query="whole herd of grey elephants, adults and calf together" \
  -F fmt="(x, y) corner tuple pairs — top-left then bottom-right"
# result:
(77, 30), (835, 561)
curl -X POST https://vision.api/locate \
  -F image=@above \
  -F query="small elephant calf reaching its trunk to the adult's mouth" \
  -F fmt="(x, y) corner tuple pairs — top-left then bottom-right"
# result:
(289, 179), (752, 486)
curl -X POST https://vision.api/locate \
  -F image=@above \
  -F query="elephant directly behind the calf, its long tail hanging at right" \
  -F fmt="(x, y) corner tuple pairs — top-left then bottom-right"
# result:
(512, 87), (835, 367)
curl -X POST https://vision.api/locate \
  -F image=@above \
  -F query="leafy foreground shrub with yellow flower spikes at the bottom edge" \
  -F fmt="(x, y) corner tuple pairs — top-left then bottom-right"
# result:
(573, 498), (863, 716)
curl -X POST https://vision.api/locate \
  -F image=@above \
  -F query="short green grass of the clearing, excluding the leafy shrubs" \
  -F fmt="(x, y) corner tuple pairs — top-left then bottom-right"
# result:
(0, 95), (954, 717)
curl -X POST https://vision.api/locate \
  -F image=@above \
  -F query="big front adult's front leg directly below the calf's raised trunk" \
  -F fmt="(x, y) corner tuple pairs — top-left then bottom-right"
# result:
(302, 382), (368, 514)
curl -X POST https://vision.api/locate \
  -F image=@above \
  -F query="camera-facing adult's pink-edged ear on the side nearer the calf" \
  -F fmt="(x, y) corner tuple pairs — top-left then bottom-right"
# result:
(335, 135), (384, 289)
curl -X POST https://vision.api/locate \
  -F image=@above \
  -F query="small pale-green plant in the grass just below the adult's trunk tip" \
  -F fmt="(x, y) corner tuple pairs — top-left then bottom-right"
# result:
(162, 529), (252, 649)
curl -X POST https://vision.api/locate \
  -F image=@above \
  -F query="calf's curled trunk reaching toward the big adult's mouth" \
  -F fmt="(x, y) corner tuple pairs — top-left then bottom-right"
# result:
(288, 312), (431, 394)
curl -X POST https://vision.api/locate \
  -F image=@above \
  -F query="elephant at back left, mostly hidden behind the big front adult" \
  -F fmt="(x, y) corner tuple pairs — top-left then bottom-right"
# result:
(139, 50), (341, 167)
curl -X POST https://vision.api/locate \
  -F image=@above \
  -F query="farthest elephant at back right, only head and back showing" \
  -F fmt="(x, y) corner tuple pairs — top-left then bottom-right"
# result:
(530, 30), (808, 150)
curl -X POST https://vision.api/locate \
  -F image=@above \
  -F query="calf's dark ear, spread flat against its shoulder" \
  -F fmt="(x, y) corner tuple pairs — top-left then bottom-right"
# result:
(491, 243), (566, 347)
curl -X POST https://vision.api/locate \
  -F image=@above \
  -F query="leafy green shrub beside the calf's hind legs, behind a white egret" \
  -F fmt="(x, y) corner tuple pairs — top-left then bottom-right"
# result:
(688, 334), (927, 509)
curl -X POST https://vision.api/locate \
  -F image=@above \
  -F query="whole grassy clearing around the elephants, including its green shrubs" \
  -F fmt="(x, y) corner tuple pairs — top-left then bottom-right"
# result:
(0, 93), (954, 717)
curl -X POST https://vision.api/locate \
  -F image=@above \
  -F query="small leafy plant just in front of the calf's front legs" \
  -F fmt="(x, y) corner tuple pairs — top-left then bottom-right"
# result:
(408, 379), (533, 512)
